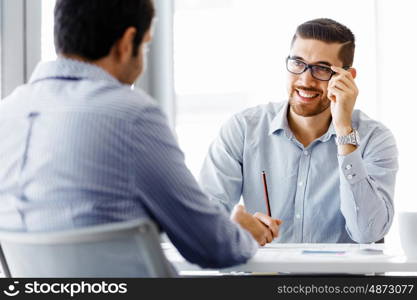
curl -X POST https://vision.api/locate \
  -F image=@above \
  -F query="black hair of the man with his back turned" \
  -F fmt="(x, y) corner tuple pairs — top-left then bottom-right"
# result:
(54, 0), (155, 60)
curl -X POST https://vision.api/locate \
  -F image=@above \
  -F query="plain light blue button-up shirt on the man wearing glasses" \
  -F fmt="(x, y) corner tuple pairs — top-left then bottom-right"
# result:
(200, 102), (398, 243)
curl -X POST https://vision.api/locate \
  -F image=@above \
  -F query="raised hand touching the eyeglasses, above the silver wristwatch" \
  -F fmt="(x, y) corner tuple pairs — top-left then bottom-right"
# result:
(327, 66), (359, 136)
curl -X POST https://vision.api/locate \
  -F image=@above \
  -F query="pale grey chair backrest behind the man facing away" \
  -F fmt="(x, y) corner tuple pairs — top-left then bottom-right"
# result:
(0, 219), (177, 277)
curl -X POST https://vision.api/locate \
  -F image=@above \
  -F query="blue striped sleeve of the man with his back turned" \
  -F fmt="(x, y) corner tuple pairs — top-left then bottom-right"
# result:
(133, 108), (257, 268)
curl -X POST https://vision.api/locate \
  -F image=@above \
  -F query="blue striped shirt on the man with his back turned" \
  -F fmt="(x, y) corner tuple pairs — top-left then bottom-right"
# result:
(0, 59), (257, 268)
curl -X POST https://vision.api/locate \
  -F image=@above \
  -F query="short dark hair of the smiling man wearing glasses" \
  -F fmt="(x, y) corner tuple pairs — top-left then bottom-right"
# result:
(291, 19), (355, 67)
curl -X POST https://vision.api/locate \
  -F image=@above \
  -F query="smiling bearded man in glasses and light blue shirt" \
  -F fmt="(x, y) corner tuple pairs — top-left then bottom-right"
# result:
(200, 19), (398, 243)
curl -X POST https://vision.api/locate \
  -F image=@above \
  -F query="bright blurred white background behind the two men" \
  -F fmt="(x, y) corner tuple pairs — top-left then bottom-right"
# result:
(0, 0), (417, 247)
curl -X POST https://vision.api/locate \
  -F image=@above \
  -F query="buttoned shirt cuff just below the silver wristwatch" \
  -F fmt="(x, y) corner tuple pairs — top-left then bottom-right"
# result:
(337, 148), (368, 184)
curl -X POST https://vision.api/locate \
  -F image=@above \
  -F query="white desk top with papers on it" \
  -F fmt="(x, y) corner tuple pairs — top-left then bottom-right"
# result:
(162, 243), (417, 274)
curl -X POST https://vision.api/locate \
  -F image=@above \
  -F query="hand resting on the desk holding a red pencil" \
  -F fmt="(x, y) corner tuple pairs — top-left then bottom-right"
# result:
(231, 204), (281, 246)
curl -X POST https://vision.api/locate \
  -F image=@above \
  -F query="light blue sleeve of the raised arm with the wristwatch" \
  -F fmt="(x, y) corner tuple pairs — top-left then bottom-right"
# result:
(338, 128), (398, 243)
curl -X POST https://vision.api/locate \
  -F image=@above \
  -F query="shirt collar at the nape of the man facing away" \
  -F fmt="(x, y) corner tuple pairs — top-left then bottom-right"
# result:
(29, 57), (122, 84)
